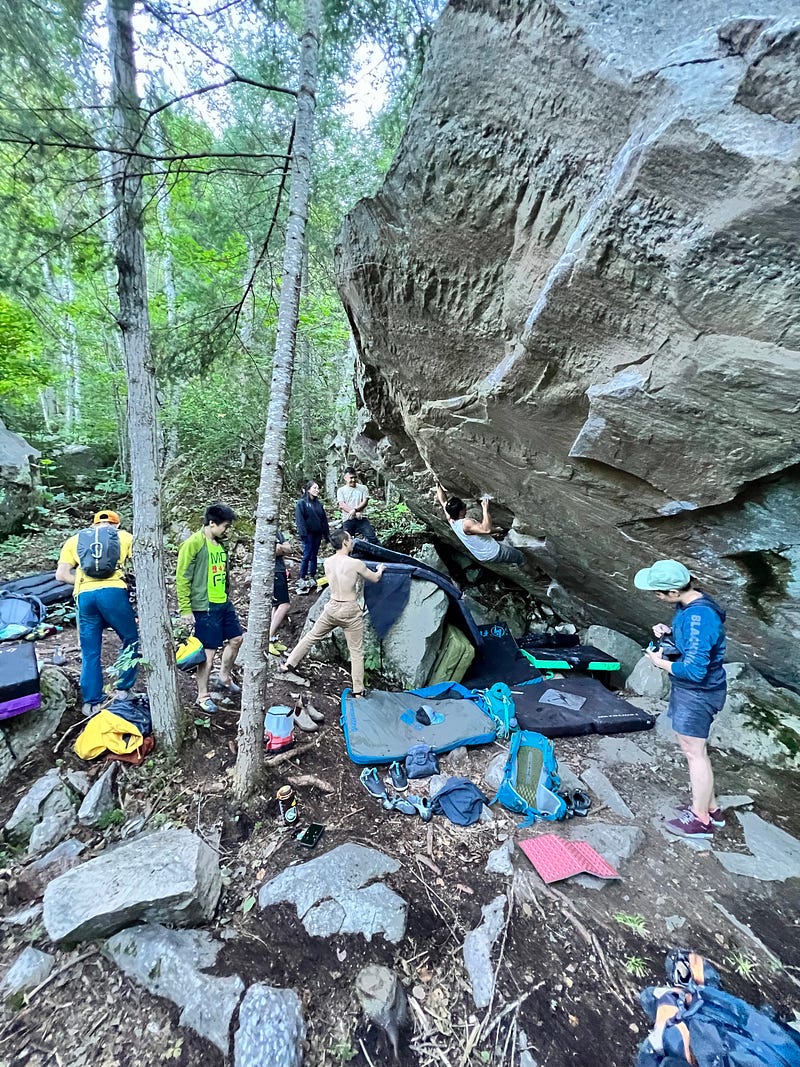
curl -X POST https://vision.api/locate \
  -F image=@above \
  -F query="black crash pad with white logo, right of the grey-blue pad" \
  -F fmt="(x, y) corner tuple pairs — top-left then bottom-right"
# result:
(513, 674), (656, 737)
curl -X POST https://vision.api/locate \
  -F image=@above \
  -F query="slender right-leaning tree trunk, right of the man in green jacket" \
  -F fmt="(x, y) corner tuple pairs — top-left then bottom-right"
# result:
(234, 0), (321, 798)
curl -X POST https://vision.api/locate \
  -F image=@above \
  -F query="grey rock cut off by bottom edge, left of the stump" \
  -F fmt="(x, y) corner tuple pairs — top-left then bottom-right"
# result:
(234, 983), (305, 1067)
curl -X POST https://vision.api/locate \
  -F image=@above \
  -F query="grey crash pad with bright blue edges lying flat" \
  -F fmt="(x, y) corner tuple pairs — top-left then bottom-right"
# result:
(341, 682), (495, 764)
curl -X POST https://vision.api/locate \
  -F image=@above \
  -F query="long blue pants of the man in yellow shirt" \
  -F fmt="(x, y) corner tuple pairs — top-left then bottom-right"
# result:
(77, 586), (139, 704)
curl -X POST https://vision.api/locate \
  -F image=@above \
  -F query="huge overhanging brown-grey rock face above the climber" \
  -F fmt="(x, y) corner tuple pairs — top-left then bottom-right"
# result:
(337, 0), (800, 682)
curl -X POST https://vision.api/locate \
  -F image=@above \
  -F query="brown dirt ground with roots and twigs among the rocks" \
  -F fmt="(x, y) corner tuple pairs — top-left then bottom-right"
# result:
(0, 546), (800, 1067)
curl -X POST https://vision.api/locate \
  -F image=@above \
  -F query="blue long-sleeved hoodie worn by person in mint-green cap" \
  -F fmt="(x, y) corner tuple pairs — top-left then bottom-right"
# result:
(672, 593), (725, 689)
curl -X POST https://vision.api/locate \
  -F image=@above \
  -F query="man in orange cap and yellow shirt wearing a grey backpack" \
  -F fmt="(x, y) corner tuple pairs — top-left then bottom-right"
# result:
(55, 508), (139, 716)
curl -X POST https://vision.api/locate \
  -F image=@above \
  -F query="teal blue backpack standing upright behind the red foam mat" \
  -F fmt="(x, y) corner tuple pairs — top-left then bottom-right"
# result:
(492, 730), (566, 826)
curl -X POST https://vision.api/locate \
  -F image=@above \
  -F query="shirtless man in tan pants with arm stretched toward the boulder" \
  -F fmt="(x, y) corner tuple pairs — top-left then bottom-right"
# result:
(278, 530), (384, 697)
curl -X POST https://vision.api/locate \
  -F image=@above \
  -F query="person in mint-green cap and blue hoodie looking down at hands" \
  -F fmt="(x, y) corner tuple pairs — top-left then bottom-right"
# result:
(634, 559), (726, 839)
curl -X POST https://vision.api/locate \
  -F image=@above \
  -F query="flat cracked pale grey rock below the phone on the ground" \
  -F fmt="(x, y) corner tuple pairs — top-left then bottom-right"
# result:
(258, 843), (407, 942)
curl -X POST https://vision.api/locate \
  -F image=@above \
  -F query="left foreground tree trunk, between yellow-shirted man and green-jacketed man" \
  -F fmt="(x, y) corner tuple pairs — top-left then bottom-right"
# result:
(107, 0), (180, 749)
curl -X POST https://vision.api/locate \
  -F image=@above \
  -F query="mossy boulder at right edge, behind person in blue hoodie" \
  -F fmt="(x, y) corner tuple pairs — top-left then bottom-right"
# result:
(710, 664), (800, 767)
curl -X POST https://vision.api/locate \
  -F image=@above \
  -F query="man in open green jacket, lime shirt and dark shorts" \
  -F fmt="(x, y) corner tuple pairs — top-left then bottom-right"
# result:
(175, 504), (242, 715)
